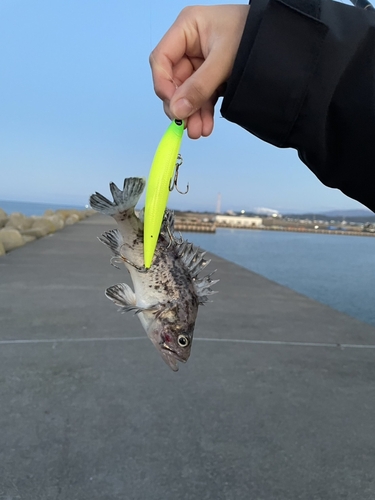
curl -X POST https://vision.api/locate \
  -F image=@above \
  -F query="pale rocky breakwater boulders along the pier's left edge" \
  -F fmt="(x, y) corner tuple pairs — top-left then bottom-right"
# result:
(0, 208), (94, 255)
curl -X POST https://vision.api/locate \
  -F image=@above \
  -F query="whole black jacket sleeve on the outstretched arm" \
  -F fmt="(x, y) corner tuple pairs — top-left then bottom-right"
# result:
(221, 0), (375, 211)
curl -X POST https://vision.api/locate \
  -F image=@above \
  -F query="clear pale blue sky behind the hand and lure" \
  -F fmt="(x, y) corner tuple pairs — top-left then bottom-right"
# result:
(0, 0), (368, 211)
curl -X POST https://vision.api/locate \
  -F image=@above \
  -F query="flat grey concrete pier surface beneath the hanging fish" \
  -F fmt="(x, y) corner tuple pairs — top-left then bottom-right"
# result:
(0, 216), (375, 500)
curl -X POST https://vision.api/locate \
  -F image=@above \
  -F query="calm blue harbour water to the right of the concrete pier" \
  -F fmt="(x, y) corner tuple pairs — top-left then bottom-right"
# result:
(184, 228), (375, 325)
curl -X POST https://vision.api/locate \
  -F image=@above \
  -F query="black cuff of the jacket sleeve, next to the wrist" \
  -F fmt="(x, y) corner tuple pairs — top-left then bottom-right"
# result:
(221, 0), (328, 147)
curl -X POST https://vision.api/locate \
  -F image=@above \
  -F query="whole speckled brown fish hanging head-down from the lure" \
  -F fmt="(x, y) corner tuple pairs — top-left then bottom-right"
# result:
(90, 177), (219, 371)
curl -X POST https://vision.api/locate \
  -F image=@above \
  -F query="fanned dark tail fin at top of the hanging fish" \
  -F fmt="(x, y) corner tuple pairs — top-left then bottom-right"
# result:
(90, 177), (146, 216)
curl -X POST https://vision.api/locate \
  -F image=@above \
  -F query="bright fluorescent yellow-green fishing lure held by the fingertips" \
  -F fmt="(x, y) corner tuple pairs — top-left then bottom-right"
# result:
(143, 120), (184, 269)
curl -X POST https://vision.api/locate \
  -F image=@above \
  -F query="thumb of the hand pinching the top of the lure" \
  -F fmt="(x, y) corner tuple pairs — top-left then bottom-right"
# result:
(169, 51), (229, 120)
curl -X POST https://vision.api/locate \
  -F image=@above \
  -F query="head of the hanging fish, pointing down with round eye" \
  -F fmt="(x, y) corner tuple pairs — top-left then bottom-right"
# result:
(147, 321), (194, 372)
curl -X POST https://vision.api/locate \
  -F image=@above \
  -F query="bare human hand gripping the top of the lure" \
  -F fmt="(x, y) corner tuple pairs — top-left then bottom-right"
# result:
(150, 5), (249, 139)
